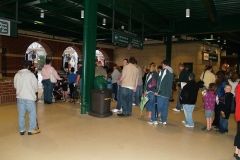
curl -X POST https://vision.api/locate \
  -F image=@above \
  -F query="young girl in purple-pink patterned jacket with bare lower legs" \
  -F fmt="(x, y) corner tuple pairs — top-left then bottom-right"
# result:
(202, 83), (217, 131)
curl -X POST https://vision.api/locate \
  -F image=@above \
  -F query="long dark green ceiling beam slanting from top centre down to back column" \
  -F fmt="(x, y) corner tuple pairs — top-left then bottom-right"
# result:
(98, 0), (172, 32)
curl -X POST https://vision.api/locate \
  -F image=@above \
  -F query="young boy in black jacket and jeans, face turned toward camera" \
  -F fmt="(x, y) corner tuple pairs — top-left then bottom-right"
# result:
(218, 85), (233, 134)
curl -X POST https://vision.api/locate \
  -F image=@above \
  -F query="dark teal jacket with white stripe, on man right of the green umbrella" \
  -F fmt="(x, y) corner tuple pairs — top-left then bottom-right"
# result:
(156, 66), (173, 98)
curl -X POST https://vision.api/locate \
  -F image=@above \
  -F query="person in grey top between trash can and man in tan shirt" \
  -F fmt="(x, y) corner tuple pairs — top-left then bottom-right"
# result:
(111, 64), (121, 101)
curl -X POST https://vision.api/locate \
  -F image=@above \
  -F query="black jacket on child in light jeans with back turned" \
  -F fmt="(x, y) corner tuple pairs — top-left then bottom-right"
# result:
(180, 80), (199, 104)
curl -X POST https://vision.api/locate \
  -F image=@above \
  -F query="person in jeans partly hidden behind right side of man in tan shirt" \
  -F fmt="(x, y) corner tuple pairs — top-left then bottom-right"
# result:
(133, 61), (143, 106)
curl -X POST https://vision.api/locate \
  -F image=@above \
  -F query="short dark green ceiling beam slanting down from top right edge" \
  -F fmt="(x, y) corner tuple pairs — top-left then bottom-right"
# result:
(202, 0), (217, 24)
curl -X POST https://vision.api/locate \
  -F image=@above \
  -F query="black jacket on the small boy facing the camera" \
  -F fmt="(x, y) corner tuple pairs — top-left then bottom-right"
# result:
(218, 92), (233, 119)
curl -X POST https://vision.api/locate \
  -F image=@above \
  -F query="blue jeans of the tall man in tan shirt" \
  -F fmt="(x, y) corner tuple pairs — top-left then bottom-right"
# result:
(121, 87), (133, 114)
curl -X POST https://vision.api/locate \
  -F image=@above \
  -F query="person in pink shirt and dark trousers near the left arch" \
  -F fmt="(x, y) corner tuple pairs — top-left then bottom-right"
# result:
(41, 59), (62, 104)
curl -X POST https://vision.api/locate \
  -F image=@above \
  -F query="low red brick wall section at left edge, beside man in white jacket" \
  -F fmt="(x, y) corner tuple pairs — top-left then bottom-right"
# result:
(0, 81), (17, 105)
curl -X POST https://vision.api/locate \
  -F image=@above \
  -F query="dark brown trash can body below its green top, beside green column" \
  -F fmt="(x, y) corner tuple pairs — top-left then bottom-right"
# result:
(89, 89), (113, 118)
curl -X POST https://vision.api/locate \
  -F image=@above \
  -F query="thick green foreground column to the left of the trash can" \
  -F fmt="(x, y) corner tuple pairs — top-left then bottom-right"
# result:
(81, 0), (98, 114)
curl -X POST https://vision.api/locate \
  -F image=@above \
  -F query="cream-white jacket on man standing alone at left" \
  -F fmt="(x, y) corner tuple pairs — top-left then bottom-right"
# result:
(14, 69), (38, 101)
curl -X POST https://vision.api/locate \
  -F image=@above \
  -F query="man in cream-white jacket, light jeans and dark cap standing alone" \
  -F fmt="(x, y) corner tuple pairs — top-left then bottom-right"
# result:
(14, 60), (40, 135)
